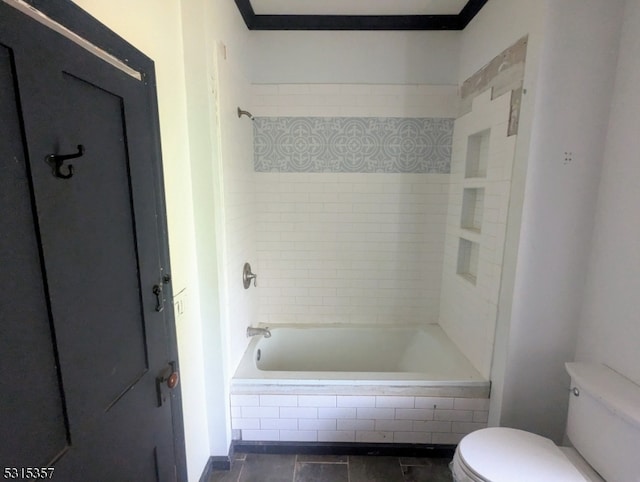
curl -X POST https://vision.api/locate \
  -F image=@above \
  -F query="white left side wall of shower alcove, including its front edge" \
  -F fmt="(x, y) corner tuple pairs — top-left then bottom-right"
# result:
(191, 0), (257, 456)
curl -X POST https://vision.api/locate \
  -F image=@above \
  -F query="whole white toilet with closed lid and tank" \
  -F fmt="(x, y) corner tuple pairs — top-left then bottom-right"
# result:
(451, 363), (640, 482)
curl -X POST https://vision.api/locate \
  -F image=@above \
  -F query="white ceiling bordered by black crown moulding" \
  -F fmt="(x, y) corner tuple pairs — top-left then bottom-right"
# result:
(235, 0), (488, 30)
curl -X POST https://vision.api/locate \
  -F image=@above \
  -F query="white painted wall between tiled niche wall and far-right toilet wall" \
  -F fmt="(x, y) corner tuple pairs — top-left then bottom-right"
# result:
(459, 0), (624, 441)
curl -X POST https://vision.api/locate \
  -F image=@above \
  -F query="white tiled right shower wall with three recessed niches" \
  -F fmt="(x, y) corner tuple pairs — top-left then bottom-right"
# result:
(438, 49), (524, 379)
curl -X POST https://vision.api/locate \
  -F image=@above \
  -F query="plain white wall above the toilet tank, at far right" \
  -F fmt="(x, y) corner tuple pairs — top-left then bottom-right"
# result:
(576, 0), (640, 384)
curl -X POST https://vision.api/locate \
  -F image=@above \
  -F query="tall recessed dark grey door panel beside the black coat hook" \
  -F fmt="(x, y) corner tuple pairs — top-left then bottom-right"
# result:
(45, 71), (148, 418)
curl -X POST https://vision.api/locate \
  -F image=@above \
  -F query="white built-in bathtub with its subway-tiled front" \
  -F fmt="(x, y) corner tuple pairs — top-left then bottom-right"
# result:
(230, 325), (490, 445)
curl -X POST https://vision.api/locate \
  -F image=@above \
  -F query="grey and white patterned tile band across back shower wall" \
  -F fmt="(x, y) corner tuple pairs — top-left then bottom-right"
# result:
(253, 117), (454, 174)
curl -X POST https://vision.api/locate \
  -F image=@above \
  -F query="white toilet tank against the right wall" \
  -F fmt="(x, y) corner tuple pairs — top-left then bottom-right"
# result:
(566, 363), (640, 482)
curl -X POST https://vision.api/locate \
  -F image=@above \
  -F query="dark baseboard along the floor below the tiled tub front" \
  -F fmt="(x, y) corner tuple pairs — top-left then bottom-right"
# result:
(232, 440), (456, 458)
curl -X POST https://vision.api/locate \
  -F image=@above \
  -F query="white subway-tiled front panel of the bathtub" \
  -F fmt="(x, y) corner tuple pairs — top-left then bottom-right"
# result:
(231, 394), (489, 444)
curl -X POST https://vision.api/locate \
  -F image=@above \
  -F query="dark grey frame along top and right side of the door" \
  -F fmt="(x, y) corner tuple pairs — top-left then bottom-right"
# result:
(15, 0), (187, 481)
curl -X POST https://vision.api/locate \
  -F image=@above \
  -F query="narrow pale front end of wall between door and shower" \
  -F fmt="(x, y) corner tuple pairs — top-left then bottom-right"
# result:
(181, 0), (231, 460)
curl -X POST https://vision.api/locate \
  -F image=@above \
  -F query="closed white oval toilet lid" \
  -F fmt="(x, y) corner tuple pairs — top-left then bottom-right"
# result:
(458, 427), (586, 482)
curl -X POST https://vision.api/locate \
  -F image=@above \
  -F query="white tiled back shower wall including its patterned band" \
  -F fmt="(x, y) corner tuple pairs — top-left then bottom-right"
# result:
(252, 84), (457, 324)
